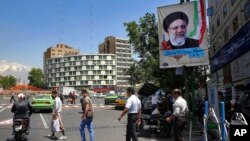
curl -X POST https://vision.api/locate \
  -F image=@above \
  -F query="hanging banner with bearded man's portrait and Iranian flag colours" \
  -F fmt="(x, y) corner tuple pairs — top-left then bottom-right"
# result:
(157, 0), (209, 68)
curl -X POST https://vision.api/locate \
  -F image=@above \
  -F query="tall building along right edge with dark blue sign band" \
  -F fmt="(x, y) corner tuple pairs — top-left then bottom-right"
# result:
(208, 0), (250, 99)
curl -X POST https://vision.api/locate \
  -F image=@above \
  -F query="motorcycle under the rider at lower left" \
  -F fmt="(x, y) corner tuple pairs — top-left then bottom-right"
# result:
(13, 119), (29, 141)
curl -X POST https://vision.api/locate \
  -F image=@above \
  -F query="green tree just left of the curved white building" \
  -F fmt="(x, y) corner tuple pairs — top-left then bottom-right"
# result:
(28, 68), (45, 88)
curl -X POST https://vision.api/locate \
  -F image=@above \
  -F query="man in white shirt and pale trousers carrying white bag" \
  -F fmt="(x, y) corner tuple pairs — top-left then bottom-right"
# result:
(48, 90), (66, 140)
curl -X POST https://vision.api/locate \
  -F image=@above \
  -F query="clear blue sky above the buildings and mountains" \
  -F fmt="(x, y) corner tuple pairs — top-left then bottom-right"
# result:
(0, 0), (184, 68)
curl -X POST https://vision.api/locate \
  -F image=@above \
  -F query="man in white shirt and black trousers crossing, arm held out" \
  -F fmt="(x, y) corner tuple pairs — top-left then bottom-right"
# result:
(118, 87), (141, 141)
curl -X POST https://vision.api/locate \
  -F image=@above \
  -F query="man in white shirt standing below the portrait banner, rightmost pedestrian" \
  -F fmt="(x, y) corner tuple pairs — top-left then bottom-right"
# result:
(166, 89), (188, 141)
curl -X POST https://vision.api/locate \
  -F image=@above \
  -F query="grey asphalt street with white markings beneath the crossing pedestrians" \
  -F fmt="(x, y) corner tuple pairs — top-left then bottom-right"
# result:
(0, 99), (215, 141)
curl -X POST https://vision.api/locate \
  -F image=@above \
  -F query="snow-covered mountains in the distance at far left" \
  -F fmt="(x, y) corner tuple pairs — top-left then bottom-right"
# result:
(0, 60), (31, 84)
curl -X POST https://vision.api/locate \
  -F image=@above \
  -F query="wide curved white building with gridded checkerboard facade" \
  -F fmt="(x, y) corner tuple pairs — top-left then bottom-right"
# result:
(45, 54), (116, 89)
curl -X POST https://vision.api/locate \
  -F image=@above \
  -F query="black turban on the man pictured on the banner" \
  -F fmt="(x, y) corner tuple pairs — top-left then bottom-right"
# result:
(163, 11), (188, 32)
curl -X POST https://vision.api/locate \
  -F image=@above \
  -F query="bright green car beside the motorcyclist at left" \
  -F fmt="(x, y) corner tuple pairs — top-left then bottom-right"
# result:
(31, 94), (54, 112)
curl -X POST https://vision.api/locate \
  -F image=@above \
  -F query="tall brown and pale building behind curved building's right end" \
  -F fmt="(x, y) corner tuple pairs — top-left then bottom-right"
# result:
(99, 36), (132, 89)
